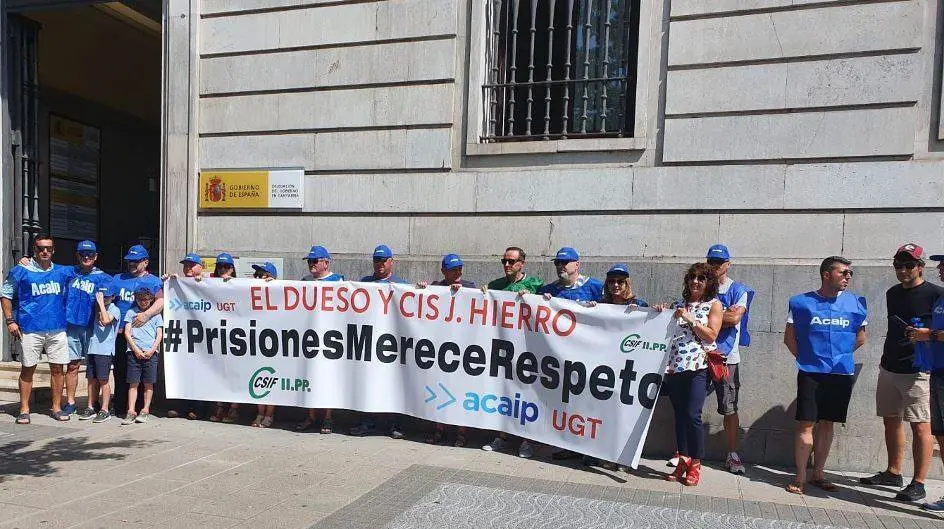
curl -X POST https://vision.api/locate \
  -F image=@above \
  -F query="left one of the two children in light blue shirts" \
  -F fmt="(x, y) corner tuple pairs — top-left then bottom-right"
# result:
(79, 283), (121, 423)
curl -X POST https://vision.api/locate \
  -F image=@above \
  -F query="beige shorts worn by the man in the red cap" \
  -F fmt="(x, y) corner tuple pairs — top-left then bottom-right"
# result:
(875, 367), (931, 422)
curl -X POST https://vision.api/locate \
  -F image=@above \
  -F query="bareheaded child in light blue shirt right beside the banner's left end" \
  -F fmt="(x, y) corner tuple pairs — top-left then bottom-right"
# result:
(121, 286), (164, 425)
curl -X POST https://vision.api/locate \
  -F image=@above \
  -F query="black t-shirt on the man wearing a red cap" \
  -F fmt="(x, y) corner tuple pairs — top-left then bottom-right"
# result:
(881, 281), (944, 373)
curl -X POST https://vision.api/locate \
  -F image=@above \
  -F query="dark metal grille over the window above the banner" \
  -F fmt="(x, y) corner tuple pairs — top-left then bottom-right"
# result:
(482, 0), (639, 142)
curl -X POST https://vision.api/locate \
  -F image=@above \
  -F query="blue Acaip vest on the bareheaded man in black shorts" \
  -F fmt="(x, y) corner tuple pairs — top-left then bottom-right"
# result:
(790, 292), (868, 375)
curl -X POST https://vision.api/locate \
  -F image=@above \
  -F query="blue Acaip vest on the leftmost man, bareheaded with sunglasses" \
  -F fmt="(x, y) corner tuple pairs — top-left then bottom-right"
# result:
(2, 261), (75, 333)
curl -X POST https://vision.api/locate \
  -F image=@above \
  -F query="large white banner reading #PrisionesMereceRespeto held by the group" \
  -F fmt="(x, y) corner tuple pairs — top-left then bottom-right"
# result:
(164, 279), (676, 467)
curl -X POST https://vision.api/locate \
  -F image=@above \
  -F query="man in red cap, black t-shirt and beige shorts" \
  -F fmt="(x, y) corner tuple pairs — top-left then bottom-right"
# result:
(859, 243), (944, 501)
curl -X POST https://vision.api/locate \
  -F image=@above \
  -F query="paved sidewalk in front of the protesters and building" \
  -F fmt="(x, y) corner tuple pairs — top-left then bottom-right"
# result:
(0, 406), (944, 529)
